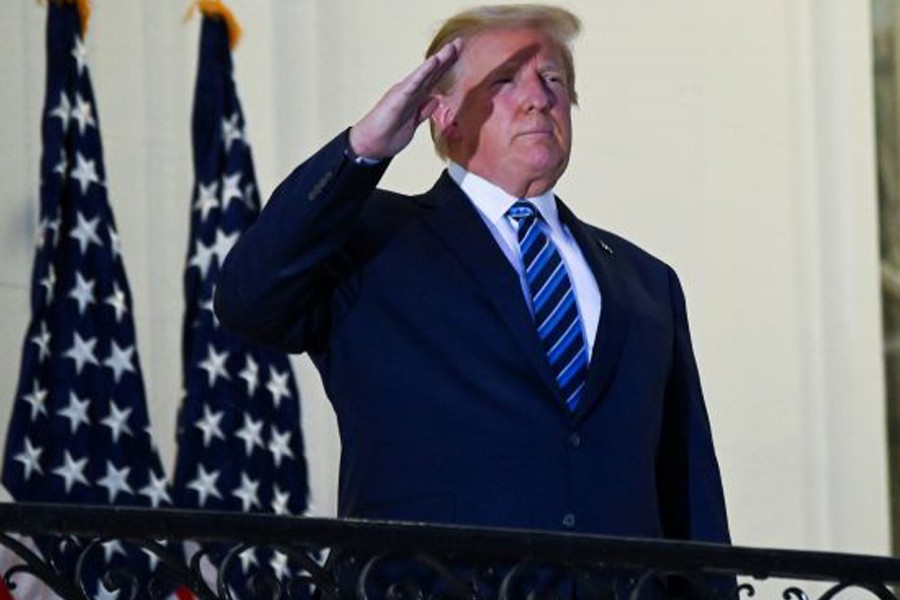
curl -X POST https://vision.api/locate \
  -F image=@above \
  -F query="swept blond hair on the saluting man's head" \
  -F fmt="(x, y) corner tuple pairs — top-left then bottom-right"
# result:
(425, 4), (581, 158)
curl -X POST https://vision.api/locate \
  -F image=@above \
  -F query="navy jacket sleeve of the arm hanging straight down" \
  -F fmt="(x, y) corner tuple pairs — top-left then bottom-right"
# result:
(656, 269), (730, 543)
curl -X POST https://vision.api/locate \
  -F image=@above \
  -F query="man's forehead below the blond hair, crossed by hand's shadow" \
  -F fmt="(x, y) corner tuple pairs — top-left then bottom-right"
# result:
(460, 27), (563, 72)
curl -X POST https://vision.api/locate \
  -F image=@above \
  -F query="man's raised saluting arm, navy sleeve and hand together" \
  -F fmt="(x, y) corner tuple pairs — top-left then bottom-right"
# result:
(215, 40), (461, 352)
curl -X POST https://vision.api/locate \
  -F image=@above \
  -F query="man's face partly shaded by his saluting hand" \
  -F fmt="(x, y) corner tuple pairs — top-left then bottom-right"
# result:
(435, 29), (572, 197)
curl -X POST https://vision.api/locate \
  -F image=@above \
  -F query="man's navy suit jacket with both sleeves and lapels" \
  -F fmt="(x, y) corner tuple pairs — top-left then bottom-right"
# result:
(216, 132), (728, 542)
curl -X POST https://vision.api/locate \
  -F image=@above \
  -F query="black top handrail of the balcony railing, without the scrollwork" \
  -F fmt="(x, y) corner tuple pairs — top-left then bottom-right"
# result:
(0, 502), (900, 585)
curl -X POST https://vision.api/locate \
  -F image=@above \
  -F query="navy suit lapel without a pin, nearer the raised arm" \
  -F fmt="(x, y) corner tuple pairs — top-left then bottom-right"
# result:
(416, 171), (563, 400)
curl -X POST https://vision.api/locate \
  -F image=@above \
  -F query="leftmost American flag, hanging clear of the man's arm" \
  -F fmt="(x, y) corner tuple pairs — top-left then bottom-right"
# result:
(3, 2), (171, 598)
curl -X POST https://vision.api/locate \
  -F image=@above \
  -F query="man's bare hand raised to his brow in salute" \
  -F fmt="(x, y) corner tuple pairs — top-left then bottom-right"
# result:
(350, 38), (462, 158)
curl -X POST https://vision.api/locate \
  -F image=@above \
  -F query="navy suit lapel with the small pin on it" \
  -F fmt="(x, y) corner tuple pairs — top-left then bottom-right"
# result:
(557, 198), (632, 418)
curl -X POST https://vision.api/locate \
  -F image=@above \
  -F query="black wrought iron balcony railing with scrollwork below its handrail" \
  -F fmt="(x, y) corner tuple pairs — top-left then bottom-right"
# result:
(0, 503), (900, 600)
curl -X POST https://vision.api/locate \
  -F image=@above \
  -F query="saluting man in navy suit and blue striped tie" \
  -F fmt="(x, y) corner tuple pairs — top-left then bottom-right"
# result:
(216, 6), (728, 542)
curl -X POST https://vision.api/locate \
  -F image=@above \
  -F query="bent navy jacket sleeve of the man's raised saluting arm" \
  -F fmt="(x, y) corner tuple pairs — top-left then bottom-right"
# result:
(215, 131), (390, 352)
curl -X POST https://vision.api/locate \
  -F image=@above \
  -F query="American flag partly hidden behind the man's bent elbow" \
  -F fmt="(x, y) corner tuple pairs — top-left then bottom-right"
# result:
(174, 2), (307, 579)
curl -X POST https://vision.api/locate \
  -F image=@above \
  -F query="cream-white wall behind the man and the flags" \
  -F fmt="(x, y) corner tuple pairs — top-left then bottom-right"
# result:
(0, 0), (889, 554)
